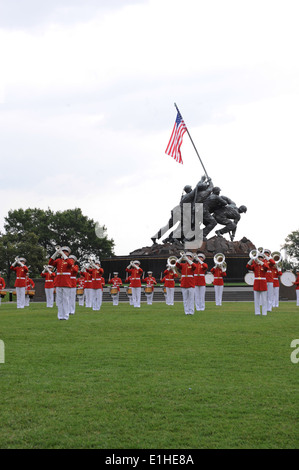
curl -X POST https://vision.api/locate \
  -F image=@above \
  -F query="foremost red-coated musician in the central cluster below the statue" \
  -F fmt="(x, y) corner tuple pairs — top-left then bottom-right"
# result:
(176, 251), (196, 315)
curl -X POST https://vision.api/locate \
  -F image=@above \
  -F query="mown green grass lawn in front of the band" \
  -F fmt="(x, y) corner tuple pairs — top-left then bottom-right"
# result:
(0, 302), (299, 449)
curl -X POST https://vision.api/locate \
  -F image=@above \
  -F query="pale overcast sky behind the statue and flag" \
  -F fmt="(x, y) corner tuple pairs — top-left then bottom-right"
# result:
(0, 0), (299, 255)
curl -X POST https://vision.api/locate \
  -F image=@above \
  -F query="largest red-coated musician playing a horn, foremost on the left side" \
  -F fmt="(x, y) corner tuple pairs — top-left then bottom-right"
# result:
(49, 246), (74, 320)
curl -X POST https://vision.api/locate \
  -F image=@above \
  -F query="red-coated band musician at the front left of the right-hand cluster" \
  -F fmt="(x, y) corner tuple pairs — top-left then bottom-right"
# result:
(246, 252), (269, 315)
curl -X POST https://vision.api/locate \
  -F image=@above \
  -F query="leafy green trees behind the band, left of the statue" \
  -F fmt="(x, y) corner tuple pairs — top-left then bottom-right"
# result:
(0, 208), (114, 286)
